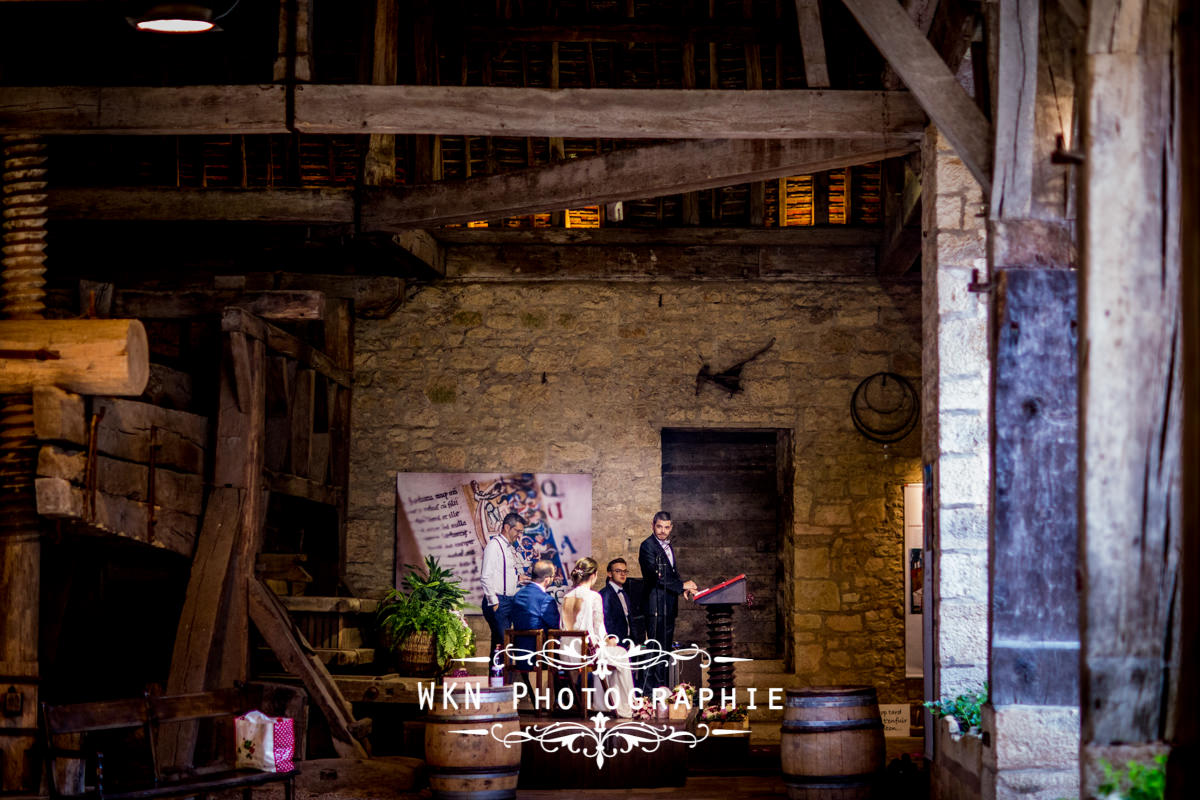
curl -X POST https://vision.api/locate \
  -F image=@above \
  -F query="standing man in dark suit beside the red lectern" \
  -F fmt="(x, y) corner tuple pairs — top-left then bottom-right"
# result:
(637, 511), (697, 693)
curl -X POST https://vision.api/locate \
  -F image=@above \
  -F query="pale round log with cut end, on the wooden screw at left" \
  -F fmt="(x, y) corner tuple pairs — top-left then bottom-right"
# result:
(0, 319), (150, 397)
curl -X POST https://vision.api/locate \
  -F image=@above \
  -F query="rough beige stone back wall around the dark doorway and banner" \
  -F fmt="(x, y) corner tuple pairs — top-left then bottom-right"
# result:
(347, 278), (920, 702)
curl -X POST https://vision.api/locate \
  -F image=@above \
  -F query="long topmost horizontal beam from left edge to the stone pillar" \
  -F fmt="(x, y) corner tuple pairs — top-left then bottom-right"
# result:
(0, 84), (925, 142)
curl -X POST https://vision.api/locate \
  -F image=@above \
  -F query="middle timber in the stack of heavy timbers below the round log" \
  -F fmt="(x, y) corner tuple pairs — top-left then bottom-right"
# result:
(37, 445), (204, 517)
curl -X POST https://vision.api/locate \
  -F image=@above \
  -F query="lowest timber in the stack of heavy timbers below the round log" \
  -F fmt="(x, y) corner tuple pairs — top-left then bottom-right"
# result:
(36, 477), (198, 558)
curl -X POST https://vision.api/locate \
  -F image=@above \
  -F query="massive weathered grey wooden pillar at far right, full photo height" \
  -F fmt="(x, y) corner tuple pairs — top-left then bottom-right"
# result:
(1080, 0), (1180, 796)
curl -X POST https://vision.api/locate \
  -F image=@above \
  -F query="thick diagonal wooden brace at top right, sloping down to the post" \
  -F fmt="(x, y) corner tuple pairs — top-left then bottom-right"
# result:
(842, 0), (991, 190)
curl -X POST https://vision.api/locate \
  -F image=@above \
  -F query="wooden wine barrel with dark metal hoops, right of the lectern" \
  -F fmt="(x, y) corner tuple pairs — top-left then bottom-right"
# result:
(780, 686), (884, 800)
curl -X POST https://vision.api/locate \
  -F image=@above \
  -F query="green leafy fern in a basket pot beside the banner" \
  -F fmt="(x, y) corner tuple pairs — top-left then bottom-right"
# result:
(377, 557), (475, 675)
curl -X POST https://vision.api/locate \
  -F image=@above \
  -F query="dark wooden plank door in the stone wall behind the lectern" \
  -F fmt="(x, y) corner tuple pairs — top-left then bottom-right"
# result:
(662, 429), (787, 658)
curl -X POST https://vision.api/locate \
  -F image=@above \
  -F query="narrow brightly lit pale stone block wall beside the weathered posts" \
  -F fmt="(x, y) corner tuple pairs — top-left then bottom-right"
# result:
(922, 127), (991, 697)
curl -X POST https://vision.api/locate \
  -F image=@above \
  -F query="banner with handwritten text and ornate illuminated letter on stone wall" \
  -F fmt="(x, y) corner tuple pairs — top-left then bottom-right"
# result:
(396, 473), (592, 607)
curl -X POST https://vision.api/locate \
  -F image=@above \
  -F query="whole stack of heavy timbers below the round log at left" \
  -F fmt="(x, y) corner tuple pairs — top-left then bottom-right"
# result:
(34, 386), (209, 557)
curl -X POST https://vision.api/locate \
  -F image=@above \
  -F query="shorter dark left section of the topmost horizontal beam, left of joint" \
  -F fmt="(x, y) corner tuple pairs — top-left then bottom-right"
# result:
(0, 85), (288, 136)
